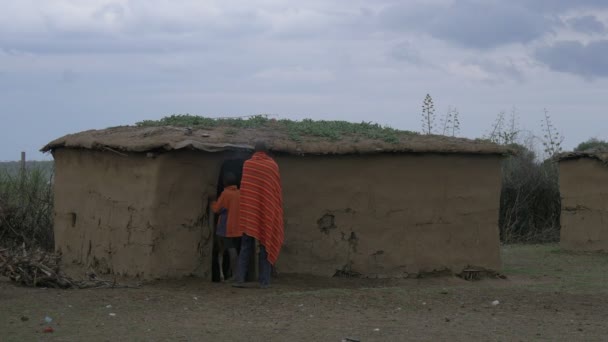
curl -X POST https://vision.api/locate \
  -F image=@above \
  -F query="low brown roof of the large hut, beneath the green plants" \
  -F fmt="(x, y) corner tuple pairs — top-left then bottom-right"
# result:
(41, 125), (511, 155)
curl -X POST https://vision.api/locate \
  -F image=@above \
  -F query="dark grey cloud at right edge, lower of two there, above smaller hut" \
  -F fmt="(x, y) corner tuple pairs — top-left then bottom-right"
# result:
(535, 40), (608, 79)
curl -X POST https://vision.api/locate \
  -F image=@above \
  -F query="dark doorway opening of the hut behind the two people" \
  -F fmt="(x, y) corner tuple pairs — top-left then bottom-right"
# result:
(211, 157), (257, 282)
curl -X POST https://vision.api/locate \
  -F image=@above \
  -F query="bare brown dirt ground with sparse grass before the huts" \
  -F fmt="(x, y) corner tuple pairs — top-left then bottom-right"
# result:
(0, 245), (608, 341)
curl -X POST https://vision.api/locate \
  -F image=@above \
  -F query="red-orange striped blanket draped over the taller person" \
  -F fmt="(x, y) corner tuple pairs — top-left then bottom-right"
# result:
(240, 152), (283, 265)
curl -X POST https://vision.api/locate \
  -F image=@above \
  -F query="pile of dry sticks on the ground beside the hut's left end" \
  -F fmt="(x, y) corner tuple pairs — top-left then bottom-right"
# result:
(0, 245), (138, 289)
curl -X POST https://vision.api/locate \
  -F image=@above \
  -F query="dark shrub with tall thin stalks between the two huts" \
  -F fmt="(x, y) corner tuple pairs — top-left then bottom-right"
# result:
(485, 108), (564, 243)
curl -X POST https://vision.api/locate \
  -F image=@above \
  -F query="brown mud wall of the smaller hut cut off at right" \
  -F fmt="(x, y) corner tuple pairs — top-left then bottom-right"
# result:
(559, 152), (608, 251)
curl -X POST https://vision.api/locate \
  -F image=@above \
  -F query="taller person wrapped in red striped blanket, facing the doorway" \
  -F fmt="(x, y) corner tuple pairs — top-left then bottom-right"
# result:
(233, 141), (283, 288)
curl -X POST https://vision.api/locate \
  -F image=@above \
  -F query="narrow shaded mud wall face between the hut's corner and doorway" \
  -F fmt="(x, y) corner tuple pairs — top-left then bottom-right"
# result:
(151, 151), (223, 279)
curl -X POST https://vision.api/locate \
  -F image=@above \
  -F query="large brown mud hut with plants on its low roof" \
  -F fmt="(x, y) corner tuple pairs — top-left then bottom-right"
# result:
(42, 122), (507, 278)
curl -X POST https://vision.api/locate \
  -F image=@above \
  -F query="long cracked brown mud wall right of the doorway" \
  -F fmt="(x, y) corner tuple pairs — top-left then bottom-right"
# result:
(277, 154), (501, 277)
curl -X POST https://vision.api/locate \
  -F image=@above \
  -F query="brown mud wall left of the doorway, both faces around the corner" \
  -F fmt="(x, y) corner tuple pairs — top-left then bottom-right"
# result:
(54, 149), (221, 278)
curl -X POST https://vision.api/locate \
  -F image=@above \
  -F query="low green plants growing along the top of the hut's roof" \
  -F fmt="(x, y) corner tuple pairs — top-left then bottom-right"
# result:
(136, 114), (418, 143)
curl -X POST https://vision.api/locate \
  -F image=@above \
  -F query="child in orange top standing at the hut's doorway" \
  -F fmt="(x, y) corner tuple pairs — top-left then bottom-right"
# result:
(211, 173), (243, 281)
